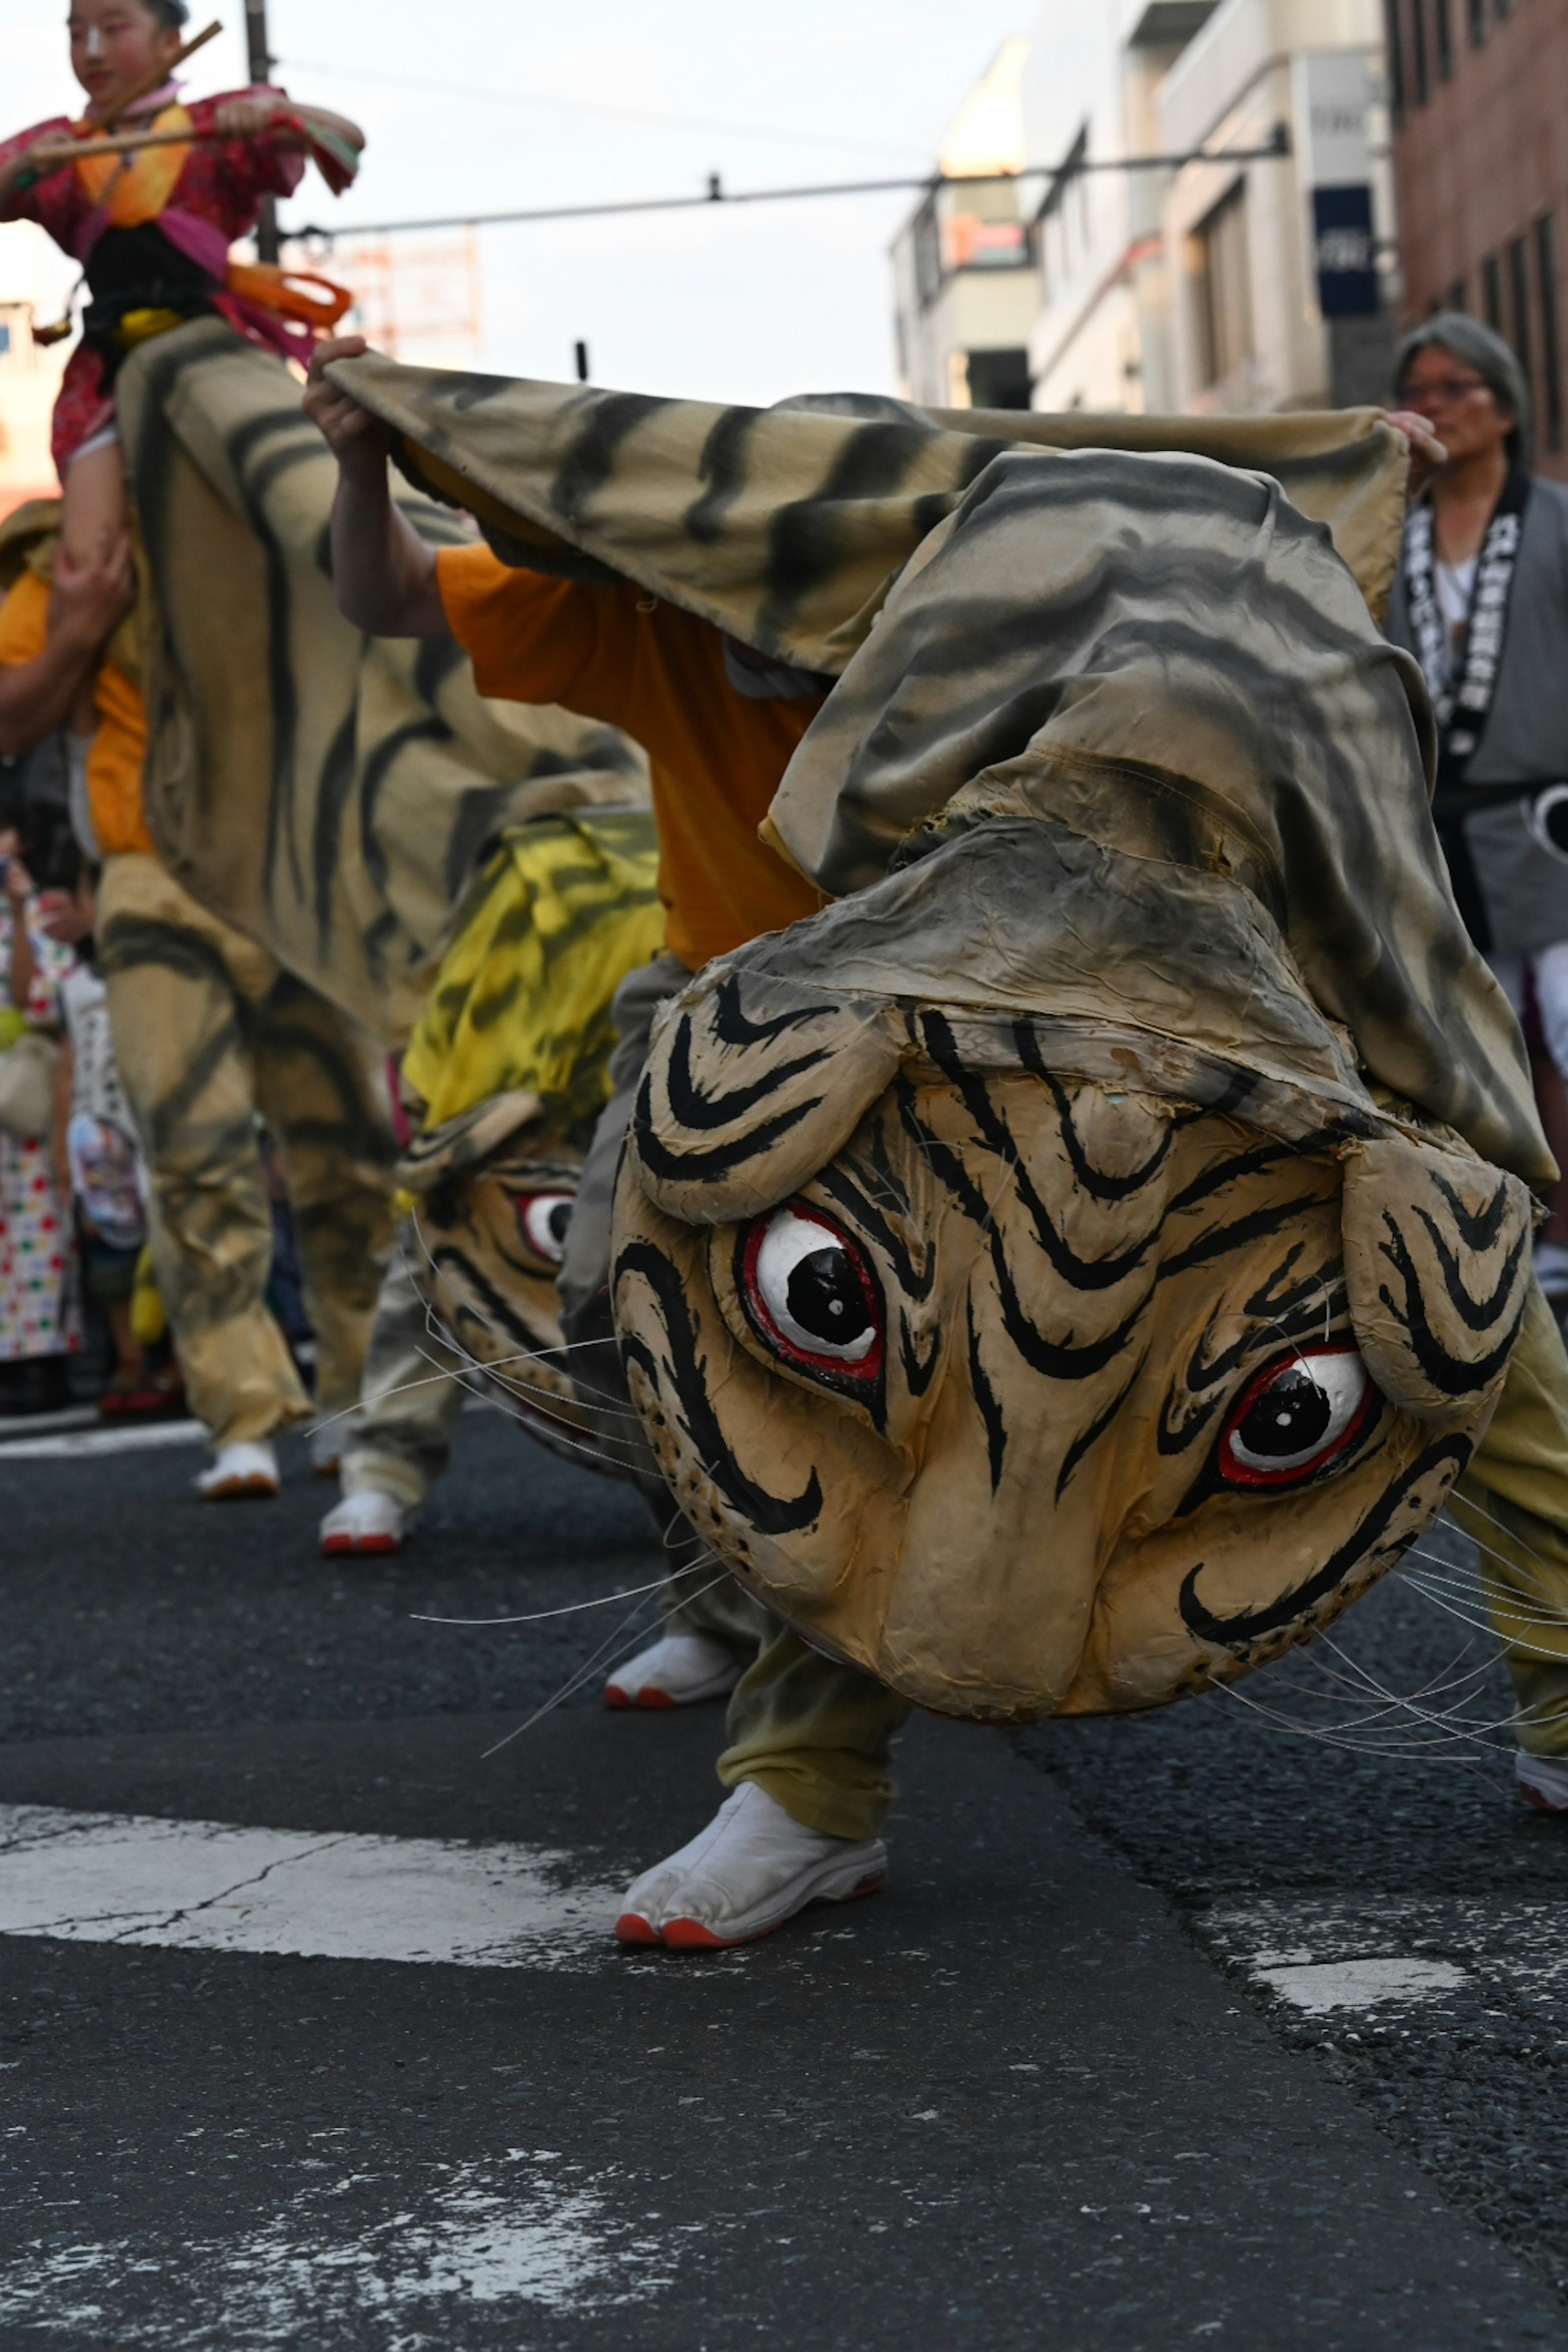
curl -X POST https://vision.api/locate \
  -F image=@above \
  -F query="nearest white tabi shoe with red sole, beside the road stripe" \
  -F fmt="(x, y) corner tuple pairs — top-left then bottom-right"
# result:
(616, 1780), (886, 1952)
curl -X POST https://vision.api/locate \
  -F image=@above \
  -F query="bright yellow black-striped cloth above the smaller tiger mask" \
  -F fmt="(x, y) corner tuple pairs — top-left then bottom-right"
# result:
(402, 809), (665, 1129)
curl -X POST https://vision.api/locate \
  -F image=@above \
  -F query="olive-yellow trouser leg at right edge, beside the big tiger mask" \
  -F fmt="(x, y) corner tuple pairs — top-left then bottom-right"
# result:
(1448, 1284), (1568, 1768)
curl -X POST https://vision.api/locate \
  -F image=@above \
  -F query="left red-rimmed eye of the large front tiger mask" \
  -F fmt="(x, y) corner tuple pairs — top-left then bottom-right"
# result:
(740, 1207), (882, 1385)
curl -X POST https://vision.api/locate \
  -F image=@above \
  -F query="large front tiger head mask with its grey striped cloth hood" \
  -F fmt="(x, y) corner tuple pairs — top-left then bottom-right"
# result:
(614, 456), (1552, 1719)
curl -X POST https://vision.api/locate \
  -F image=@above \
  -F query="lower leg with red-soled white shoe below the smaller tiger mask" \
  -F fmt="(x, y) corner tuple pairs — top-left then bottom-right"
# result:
(322, 1223), (468, 1552)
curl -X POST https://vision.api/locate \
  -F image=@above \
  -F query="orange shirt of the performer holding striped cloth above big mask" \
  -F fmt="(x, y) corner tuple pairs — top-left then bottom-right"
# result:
(435, 546), (825, 969)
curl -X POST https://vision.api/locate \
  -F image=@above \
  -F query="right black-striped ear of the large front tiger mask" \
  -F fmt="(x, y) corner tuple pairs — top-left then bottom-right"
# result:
(1342, 1136), (1533, 1421)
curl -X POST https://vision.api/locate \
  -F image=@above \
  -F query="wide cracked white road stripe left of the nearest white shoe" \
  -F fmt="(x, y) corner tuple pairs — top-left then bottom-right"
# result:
(0, 1804), (623, 1969)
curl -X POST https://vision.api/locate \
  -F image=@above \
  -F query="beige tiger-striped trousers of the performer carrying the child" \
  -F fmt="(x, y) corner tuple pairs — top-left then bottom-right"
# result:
(99, 854), (392, 1446)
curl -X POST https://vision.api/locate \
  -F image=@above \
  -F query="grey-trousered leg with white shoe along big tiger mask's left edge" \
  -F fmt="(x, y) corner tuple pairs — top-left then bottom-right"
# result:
(559, 955), (773, 1705)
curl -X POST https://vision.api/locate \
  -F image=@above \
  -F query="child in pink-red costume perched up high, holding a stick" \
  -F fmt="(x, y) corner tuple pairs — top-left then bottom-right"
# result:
(0, 0), (364, 706)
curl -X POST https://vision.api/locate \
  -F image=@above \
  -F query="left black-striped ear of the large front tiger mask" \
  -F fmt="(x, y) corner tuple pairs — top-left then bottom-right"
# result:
(630, 964), (910, 1225)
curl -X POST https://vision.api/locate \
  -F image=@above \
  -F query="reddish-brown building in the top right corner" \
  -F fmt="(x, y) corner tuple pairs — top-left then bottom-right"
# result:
(1387, 0), (1568, 482)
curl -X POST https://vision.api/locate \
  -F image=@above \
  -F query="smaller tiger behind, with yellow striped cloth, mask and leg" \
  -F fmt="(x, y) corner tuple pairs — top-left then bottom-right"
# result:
(343, 809), (663, 1510)
